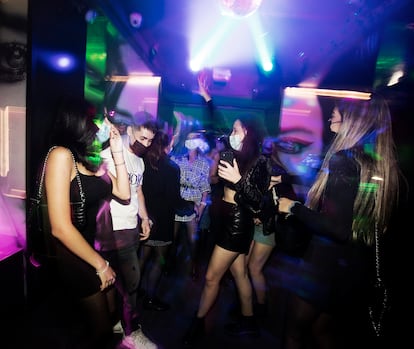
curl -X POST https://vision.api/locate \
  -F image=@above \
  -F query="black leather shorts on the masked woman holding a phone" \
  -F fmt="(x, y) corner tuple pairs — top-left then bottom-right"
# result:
(211, 200), (254, 254)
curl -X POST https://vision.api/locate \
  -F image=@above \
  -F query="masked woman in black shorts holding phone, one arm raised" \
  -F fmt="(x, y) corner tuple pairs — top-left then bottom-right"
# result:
(184, 80), (270, 347)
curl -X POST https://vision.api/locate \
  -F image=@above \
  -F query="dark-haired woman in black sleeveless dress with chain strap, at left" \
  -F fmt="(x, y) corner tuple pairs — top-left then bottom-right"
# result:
(44, 99), (130, 348)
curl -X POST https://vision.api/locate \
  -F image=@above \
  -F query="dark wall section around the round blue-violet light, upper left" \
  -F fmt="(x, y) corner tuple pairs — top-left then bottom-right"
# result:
(27, 0), (86, 196)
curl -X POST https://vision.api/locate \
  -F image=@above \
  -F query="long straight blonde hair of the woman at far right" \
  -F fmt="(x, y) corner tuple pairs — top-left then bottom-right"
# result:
(306, 96), (399, 245)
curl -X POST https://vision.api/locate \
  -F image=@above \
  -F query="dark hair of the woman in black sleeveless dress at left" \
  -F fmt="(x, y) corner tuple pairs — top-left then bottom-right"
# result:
(50, 99), (101, 172)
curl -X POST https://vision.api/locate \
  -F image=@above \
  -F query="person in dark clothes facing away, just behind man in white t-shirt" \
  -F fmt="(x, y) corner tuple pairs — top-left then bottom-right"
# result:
(140, 131), (181, 311)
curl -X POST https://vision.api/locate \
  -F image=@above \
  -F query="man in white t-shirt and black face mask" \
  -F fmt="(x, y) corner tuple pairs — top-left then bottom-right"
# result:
(95, 112), (158, 348)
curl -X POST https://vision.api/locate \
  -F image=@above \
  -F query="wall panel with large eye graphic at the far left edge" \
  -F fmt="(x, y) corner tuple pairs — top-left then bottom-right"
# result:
(0, 0), (28, 251)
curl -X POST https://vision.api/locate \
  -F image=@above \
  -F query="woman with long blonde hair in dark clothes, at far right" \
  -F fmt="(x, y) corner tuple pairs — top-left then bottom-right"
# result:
(278, 96), (399, 349)
